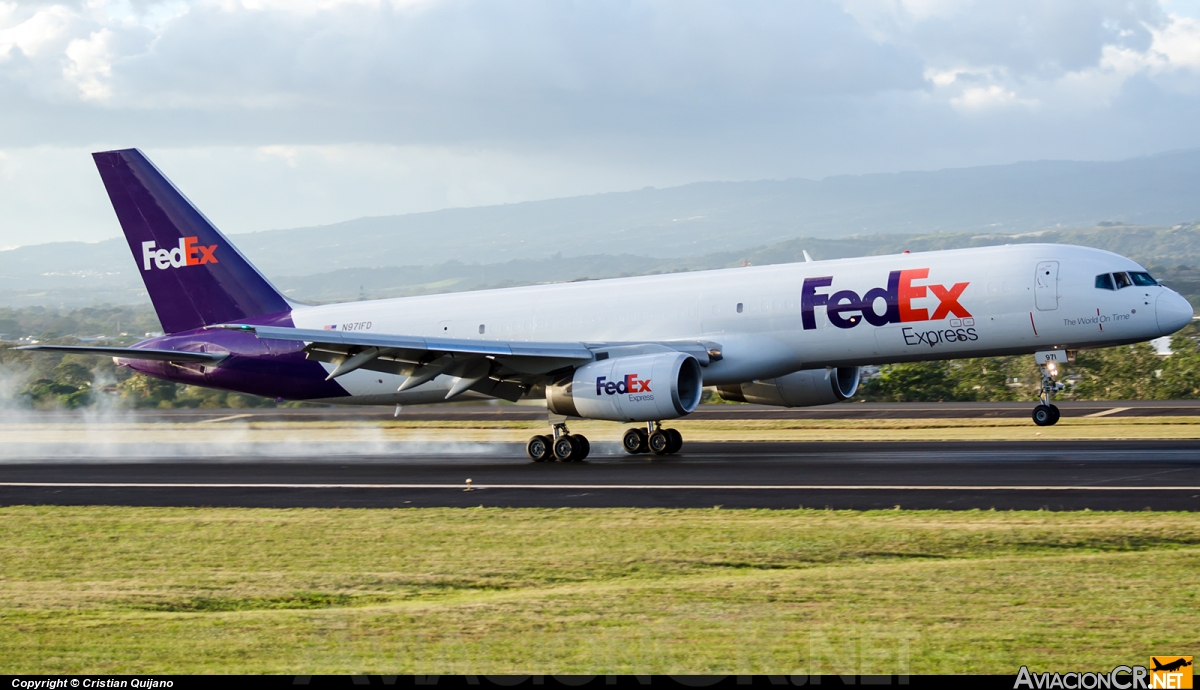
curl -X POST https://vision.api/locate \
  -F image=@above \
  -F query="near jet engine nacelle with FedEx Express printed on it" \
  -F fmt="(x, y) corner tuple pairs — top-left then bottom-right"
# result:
(546, 352), (704, 421)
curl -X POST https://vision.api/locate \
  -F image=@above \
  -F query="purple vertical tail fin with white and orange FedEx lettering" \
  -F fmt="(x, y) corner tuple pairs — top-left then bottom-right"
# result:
(92, 149), (290, 332)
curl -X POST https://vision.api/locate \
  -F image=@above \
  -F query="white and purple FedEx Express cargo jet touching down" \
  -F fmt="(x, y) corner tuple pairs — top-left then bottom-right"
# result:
(25, 149), (1193, 462)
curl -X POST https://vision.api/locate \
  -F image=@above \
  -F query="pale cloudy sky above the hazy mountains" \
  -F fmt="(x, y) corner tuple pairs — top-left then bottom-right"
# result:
(0, 0), (1200, 247)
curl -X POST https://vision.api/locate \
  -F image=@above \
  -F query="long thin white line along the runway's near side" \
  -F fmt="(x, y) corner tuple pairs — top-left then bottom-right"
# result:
(0, 481), (1200, 491)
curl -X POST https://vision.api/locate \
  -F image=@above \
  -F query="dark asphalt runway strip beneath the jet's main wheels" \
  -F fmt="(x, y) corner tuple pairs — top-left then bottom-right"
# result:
(0, 440), (1200, 511)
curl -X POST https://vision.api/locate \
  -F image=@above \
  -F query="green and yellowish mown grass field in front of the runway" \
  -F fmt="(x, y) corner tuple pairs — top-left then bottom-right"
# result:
(0, 506), (1200, 673)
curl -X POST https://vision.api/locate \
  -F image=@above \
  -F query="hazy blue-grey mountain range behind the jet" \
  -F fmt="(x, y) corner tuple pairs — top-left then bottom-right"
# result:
(0, 150), (1200, 306)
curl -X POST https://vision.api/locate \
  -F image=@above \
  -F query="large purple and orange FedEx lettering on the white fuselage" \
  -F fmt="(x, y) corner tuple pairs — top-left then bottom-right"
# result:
(800, 269), (971, 330)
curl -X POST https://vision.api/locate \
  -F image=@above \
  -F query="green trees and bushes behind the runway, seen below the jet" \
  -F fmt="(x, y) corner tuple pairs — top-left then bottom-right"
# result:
(7, 307), (1200, 409)
